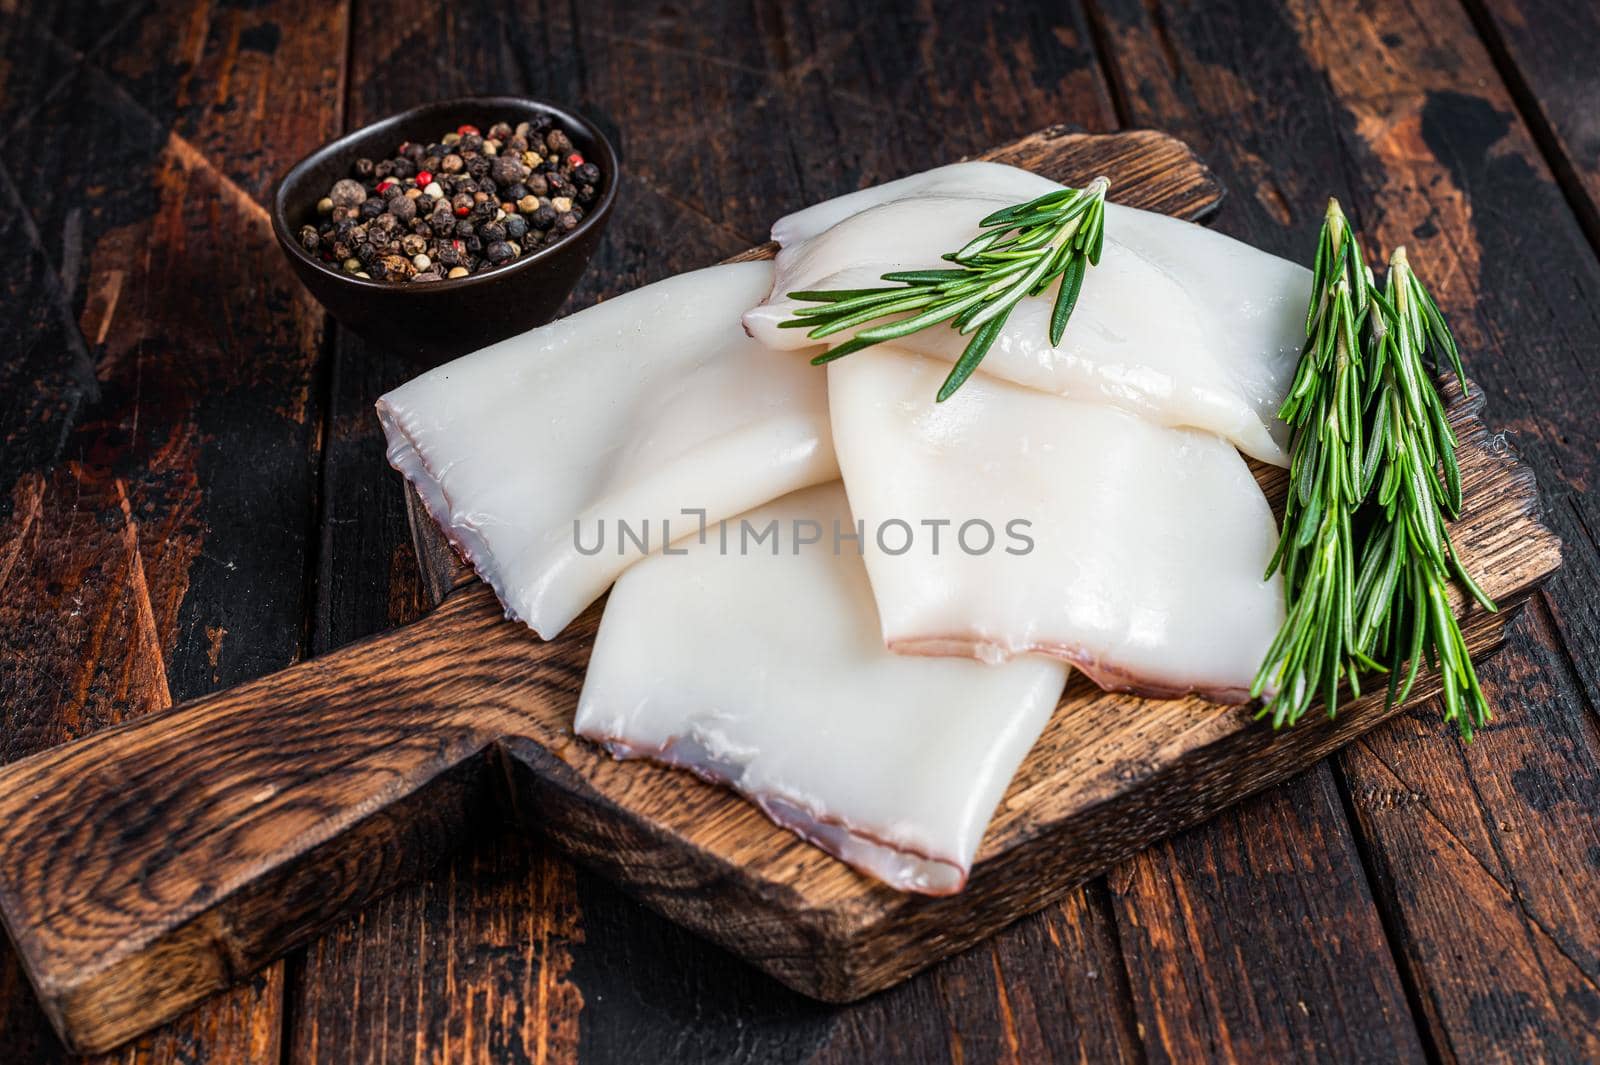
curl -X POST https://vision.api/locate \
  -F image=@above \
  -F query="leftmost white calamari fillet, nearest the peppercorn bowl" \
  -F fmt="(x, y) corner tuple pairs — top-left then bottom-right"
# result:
(378, 262), (838, 640)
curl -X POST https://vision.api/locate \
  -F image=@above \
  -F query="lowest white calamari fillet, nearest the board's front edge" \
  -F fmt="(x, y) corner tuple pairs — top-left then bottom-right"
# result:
(576, 483), (1067, 895)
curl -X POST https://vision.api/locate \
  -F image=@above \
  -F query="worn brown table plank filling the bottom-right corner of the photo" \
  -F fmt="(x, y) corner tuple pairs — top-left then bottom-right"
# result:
(1341, 608), (1600, 1062)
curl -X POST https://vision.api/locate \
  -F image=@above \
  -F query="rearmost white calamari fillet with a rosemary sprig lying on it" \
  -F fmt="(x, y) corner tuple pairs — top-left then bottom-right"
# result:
(744, 163), (1310, 465)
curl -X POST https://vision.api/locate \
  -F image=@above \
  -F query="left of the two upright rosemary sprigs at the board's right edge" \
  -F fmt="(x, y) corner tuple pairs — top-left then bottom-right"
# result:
(1250, 200), (1382, 728)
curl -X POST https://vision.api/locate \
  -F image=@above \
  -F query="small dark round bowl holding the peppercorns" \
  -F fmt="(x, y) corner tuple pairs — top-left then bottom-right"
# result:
(272, 96), (618, 365)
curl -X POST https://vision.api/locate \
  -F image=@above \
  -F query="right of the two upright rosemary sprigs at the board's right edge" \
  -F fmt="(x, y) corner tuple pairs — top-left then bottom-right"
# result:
(1357, 248), (1496, 740)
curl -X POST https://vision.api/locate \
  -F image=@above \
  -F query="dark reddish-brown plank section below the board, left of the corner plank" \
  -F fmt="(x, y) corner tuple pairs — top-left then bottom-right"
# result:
(1109, 764), (1424, 1062)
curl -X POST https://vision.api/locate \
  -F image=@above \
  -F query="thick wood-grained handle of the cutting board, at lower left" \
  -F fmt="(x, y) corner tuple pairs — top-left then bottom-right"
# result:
(0, 585), (554, 1052)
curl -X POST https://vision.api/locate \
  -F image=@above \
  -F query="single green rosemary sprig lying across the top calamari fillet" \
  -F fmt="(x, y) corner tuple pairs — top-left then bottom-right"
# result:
(781, 178), (1110, 403)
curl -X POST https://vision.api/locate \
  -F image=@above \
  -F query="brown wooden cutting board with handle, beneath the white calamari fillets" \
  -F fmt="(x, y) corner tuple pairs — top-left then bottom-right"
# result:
(0, 130), (1560, 1051)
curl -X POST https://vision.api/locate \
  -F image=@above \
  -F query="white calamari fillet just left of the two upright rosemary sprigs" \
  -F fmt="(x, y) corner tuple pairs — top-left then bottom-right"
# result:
(827, 347), (1283, 702)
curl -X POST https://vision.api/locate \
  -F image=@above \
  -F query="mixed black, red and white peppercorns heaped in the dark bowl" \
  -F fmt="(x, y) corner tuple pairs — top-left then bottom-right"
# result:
(299, 115), (600, 281)
